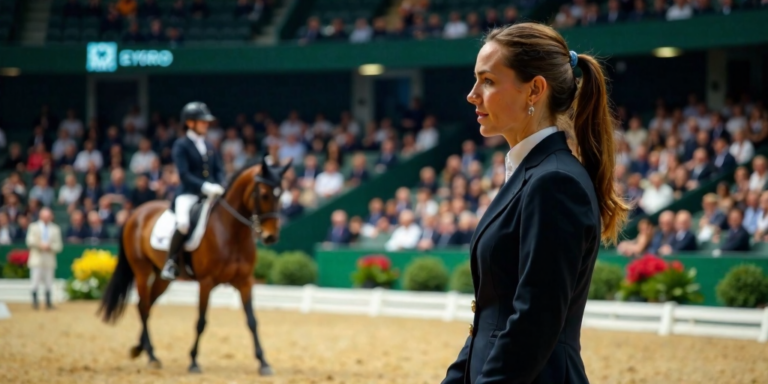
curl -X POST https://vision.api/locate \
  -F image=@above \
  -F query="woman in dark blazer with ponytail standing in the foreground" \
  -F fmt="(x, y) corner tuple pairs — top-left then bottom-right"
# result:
(443, 23), (628, 384)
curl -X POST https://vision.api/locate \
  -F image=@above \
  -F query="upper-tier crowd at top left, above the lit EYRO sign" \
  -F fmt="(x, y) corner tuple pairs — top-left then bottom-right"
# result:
(55, 0), (274, 46)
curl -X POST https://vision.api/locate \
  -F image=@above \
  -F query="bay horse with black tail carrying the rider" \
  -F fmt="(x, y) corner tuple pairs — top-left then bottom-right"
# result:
(99, 157), (291, 376)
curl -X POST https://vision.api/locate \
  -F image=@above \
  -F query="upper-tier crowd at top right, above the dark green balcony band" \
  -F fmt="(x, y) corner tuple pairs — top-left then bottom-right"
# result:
(552, 0), (768, 28)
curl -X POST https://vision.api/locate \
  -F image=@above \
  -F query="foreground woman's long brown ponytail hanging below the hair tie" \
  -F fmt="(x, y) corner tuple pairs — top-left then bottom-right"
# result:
(573, 54), (629, 244)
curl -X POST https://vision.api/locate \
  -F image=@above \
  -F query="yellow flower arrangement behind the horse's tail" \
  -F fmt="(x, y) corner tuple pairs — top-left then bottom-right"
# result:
(67, 249), (117, 300)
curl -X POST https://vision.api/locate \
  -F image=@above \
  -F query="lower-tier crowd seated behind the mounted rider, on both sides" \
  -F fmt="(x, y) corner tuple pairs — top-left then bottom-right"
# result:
(0, 100), (439, 244)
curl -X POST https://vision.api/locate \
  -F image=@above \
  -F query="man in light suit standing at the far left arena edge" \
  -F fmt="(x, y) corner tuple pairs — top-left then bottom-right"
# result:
(26, 208), (63, 309)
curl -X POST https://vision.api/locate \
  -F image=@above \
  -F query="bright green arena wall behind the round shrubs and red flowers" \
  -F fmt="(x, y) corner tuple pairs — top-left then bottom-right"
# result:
(315, 246), (768, 306)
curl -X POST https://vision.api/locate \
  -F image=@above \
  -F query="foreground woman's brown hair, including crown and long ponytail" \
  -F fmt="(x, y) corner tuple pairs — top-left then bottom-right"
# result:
(485, 23), (629, 244)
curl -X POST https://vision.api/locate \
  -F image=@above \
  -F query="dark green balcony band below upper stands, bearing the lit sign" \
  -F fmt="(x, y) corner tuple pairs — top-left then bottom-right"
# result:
(0, 10), (768, 75)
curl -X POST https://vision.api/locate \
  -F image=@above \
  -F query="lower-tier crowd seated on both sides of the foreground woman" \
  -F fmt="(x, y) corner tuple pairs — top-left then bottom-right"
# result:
(326, 94), (768, 255)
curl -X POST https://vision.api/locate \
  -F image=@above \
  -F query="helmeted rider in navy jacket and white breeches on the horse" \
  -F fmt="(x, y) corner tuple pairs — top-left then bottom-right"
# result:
(160, 102), (224, 280)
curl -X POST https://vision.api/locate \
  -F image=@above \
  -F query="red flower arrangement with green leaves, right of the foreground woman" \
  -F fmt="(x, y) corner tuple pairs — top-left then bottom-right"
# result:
(618, 255), (704, 304)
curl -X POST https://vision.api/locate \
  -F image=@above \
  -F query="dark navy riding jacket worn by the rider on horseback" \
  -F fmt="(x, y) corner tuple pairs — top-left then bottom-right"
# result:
(171, 135), (224, 196)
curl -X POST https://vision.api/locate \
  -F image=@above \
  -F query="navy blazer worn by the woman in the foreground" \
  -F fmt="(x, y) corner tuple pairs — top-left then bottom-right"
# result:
(443, 132), (601, 384)
